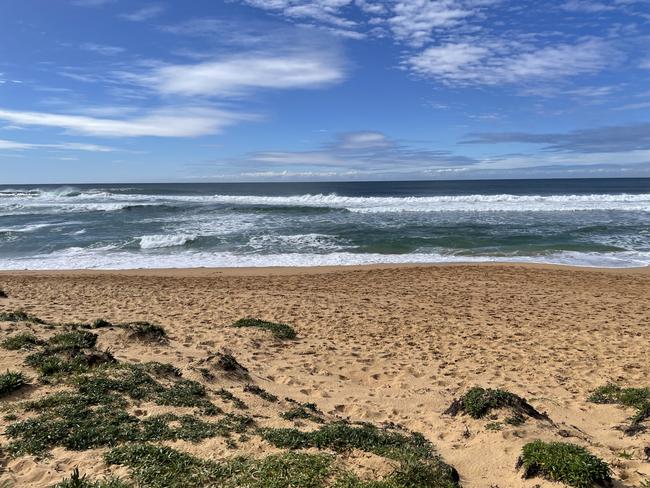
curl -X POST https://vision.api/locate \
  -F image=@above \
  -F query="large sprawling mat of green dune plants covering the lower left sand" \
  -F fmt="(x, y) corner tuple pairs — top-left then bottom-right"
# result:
(3, 325), (458, 488)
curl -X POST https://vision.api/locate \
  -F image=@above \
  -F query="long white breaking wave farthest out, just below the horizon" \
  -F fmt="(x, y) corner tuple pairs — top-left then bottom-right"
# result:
(0, 188), (650, 213)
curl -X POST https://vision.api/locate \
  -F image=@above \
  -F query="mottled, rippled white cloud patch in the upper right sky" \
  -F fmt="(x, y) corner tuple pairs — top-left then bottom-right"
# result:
(406, 40), (613, 85)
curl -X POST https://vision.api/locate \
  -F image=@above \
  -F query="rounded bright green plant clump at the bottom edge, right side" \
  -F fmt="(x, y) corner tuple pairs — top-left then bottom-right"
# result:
(517, 440), (611, 488)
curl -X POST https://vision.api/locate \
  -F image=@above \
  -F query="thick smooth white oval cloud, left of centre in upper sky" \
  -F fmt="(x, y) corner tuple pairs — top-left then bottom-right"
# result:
(129, 52), (344, 96)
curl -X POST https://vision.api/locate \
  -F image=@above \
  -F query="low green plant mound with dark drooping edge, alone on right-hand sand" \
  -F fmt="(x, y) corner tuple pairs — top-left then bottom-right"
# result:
(445, 387), (548, 423)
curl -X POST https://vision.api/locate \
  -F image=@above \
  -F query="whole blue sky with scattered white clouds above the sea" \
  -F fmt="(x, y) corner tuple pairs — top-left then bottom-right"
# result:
(0, 0), (650, 184)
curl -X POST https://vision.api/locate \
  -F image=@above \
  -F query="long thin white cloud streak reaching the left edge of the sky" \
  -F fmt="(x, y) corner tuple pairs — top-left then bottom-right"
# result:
(0, 107), (252, 137)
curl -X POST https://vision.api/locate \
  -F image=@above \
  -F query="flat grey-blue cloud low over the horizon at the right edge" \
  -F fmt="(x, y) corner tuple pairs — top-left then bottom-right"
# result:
(464, 123), (650, 153)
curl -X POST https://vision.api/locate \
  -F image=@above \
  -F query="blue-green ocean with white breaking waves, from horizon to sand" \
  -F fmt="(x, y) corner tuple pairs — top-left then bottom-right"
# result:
(0, 178), (650, 270)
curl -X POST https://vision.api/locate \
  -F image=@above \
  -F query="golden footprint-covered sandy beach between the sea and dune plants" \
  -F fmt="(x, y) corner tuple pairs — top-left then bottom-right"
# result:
(0, 264), (650, 488)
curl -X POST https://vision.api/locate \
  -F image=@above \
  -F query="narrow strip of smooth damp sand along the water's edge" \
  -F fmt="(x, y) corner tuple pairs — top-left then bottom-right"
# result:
(0, 261), (650, 276)
